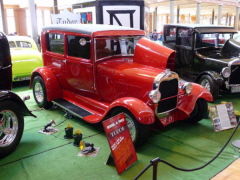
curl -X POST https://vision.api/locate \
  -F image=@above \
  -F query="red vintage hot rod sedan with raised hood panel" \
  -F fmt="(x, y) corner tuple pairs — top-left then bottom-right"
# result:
(31, 24), (212, 147)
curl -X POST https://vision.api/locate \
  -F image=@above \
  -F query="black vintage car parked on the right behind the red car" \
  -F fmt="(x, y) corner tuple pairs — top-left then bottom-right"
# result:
(163, 24), (240, 99)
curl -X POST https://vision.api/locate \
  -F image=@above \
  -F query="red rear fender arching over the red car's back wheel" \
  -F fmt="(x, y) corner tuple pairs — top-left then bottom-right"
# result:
(31, 67), (63, 102)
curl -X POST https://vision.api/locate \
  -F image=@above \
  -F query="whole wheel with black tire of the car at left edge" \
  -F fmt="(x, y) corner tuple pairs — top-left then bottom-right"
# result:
(0, 101), (24, 158)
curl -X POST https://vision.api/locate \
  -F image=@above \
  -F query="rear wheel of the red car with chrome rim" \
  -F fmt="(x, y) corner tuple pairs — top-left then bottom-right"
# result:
(33, 76), (52, 109)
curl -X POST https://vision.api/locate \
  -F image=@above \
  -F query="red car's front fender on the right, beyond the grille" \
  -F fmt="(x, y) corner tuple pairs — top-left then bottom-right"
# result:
(178, 83), (213, 115)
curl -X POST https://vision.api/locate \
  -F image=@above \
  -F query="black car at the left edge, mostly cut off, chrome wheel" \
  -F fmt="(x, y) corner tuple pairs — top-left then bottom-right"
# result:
(0, 32), (35, 159)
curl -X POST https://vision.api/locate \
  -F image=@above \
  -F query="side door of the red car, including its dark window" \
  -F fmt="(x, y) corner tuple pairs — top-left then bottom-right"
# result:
(65, 35), (96, 98)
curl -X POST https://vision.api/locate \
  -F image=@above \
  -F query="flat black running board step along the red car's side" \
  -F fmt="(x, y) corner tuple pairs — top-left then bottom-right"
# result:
(52, 98), (93, 118)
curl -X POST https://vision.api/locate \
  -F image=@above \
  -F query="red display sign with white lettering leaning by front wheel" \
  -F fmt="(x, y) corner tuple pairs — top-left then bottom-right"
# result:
(103, 113), (137, 174)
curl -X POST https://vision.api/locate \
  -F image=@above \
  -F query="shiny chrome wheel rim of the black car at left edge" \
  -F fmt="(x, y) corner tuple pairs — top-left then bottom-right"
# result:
(0, 110), (18, 147)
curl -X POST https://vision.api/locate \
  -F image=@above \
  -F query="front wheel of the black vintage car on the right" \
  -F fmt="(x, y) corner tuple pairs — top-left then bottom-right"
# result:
(199, 75), (219, 100)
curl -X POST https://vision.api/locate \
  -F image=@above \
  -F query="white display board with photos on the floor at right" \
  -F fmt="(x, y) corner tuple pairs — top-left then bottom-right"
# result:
(209, 102), (238, 132)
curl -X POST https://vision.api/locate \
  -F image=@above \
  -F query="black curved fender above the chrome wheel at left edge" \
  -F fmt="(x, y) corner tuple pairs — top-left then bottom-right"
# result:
(0, 90), (36, 117)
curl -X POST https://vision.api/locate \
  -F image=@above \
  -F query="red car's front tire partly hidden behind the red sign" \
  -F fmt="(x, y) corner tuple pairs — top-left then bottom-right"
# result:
(112, 108), (149, 148)
